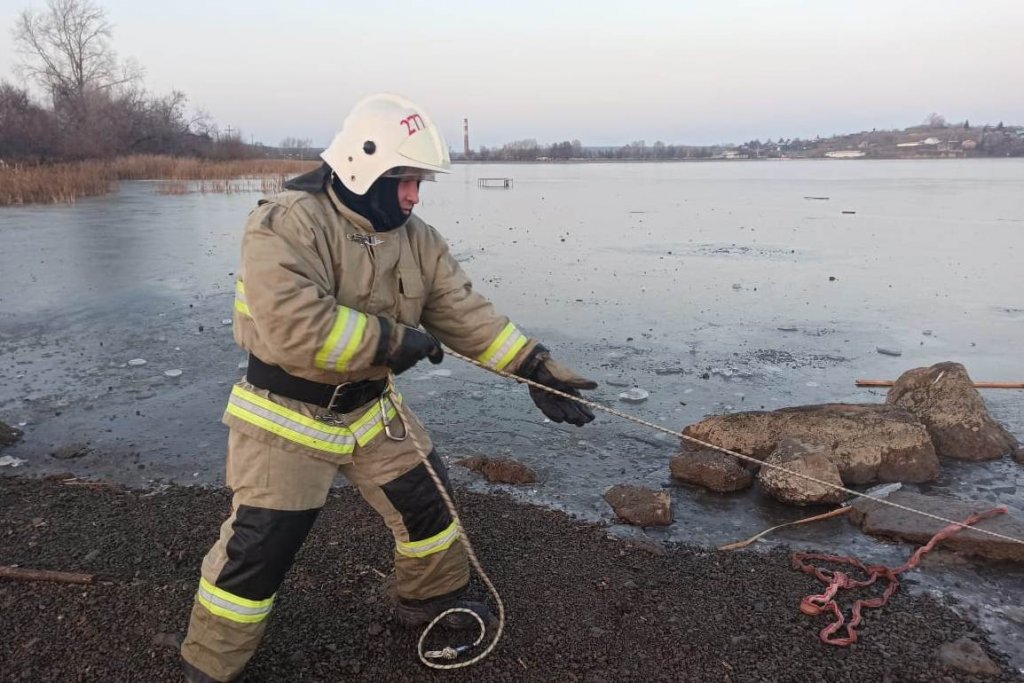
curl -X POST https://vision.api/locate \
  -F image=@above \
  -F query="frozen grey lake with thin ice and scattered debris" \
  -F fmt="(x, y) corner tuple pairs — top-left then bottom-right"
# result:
(0, 160), (1024, 666)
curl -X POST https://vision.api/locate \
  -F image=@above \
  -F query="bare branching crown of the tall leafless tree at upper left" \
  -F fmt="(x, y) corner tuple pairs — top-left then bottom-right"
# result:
(13, 0), (141, 105)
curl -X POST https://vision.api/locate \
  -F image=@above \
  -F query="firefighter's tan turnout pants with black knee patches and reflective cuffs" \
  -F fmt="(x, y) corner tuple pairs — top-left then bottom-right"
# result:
(181, 409), (469, 681)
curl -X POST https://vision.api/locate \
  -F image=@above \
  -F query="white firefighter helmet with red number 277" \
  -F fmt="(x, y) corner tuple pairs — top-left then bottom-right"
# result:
(321, 93), (452, 196)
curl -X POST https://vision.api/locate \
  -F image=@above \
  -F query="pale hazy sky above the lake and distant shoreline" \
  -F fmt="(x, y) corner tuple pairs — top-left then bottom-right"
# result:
(0, 0), (1024, 150)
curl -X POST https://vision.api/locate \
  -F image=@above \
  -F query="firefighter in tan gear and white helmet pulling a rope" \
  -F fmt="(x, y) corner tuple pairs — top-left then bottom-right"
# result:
(181, 94), (597, 681)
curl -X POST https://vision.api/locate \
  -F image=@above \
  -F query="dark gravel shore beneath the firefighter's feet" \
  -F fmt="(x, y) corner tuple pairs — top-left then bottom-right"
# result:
(0, 477), (1024, 683)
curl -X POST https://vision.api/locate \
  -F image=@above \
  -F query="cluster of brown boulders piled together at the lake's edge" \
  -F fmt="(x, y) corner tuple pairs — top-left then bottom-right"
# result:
(671, 362), (1024, 505)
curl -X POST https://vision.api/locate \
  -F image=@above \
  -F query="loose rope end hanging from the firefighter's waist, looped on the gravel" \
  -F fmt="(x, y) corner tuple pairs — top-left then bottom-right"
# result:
(387, 373), (505, 670)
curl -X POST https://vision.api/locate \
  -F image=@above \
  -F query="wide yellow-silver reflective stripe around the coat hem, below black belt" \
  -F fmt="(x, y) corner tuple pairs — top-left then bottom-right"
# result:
(226, 385), (401, 455)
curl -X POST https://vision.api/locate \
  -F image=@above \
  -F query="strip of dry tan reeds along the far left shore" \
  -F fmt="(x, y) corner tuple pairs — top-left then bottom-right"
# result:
(0, 155), (319, 206)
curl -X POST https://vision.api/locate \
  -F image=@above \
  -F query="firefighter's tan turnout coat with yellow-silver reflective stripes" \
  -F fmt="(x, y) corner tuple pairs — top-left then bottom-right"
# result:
(224, 180), (537, 463)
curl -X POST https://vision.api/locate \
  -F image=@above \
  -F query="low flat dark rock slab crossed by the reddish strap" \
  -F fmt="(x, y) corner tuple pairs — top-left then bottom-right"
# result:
(850, 490), (1024, 563)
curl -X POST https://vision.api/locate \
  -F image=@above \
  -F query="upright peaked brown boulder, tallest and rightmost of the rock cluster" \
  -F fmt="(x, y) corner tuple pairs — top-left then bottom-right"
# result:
(886, 362), (1018, 460)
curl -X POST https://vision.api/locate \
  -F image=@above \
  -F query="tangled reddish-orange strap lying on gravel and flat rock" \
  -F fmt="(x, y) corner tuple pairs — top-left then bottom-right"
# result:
(793, 507), (1007, 647)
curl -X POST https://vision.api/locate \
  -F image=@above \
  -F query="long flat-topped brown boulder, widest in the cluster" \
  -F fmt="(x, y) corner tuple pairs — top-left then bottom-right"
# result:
(683, 403), (939, 485)
